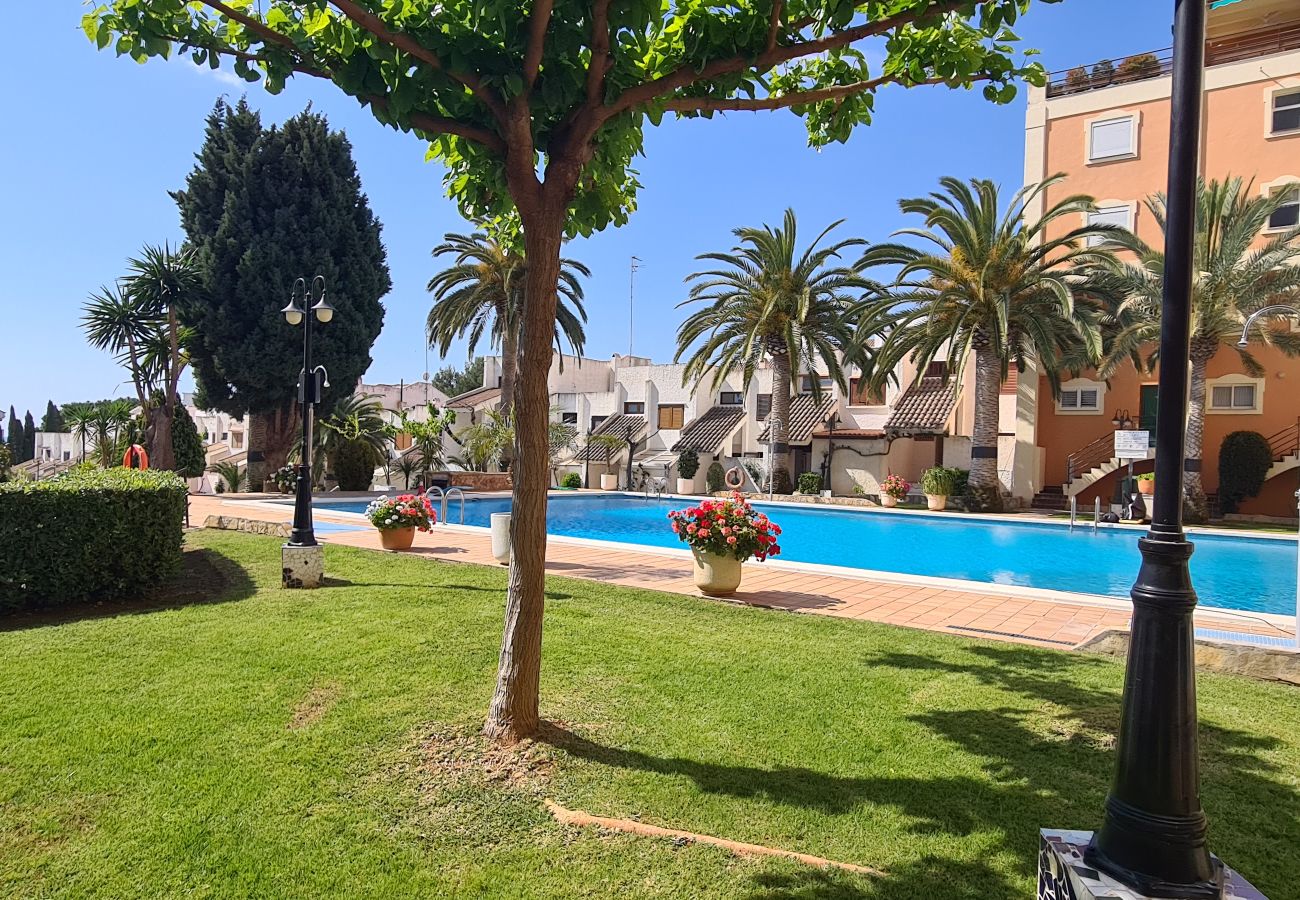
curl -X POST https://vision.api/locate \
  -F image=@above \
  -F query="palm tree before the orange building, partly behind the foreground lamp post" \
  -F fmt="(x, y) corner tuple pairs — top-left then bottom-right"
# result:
(1099, 178), (1300, 519)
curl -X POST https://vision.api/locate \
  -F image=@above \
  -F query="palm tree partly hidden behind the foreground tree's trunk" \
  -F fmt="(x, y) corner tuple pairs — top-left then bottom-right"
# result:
(425, 232), (592, 410)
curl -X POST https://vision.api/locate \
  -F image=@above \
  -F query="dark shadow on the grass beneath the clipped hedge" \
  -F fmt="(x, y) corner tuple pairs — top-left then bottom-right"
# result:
(0, 548), (256, 631)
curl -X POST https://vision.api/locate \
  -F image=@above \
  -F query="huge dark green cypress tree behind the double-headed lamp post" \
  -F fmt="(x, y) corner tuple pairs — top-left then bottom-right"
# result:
(173, 100), (391, 484)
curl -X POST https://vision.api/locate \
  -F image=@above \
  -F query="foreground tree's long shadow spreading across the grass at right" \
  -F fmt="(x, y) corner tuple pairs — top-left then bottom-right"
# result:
(542, 646), (1300, 900)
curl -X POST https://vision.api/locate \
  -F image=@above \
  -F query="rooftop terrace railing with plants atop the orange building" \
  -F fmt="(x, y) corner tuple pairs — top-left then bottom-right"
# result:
(1048, 23), (1300, 98)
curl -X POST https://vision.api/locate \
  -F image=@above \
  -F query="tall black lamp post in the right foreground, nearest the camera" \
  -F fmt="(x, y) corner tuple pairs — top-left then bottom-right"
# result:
(1086, 0), (1223, 897)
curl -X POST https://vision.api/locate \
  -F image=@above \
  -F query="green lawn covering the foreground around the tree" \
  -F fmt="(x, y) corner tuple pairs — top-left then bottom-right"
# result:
(0, 532), (1300, 900)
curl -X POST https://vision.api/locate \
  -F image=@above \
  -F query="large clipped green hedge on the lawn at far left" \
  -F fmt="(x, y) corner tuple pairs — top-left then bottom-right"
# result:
(0, 468), (186, 607)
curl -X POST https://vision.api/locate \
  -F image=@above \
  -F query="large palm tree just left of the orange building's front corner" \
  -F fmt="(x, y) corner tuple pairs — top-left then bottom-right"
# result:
(854, 176), (1122, 510)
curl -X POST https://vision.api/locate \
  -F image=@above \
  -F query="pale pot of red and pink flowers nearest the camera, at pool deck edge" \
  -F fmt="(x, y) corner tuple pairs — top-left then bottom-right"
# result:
(668, 492), (781, 597)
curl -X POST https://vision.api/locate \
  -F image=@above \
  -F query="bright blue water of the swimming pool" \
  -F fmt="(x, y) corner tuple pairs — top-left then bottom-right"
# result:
(319, 494), (1296, 615)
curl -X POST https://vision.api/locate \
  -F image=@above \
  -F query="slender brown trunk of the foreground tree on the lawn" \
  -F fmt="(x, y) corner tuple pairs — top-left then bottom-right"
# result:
(484, 201), (567, 743)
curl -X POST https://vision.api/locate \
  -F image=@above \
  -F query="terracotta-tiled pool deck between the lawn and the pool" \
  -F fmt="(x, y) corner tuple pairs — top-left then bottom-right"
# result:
(190, 496), (1295, 648)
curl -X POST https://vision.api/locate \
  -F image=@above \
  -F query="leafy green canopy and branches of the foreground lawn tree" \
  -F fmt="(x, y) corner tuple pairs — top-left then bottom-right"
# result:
(82, 0), (1057, 235)
